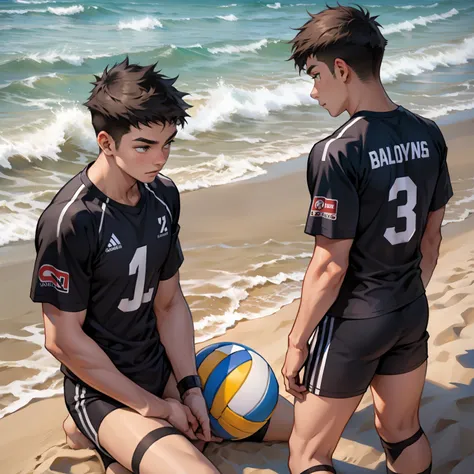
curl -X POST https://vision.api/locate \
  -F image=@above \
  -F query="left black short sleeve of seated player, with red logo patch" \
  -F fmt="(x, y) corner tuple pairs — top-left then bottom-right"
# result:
(30, 208), (92, 312)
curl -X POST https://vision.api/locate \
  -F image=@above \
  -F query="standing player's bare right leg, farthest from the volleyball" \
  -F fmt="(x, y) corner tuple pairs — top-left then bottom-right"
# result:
(371, 362), (431, 474)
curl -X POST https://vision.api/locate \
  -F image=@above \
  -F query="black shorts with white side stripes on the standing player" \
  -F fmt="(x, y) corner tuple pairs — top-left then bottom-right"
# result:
(303, 294), (429, 398)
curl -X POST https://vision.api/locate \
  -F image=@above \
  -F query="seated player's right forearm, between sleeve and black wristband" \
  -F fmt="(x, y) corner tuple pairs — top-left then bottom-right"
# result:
(154, 272), (197, 382)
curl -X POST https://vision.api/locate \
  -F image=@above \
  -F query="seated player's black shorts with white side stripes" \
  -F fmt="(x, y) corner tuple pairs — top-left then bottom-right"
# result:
(64, 363), (171, 470)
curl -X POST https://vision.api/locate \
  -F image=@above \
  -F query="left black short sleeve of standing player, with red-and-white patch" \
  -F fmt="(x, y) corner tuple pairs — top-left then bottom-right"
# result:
(305, 139), (360, 239)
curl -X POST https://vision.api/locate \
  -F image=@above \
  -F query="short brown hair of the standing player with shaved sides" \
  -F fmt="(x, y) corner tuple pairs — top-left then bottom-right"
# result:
(289, 4), (387, 80)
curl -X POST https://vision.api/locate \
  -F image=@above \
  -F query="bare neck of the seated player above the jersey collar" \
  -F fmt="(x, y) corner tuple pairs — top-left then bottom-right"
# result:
(87, 152), (140, 205)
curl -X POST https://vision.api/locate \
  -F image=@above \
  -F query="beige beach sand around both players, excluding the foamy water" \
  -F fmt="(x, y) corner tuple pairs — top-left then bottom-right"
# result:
(0, 117), (474, 474)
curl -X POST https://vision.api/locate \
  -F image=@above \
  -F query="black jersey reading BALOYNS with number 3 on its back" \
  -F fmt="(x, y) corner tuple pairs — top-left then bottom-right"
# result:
(305, 107), (453, 318)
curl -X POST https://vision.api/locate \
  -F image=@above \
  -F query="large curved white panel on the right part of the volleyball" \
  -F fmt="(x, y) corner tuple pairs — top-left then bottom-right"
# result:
(228, 351), (270, 416)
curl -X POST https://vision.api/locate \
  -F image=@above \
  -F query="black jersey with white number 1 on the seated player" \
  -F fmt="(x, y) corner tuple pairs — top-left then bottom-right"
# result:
(31, 165), (183, 391)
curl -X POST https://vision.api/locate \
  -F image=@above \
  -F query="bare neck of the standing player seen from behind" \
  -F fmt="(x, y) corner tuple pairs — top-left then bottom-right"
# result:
(346, 80), (397, 116)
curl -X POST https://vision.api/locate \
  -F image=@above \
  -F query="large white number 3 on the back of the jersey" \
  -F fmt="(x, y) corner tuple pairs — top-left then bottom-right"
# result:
(384, 176), (416, 245)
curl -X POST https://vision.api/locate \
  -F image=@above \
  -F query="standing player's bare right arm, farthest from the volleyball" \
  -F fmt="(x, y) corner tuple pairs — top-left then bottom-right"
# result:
(420, 206), (445, 288)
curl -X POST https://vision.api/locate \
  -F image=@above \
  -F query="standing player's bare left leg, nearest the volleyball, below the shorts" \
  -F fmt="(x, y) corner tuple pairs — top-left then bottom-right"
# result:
(288, 392), (362, 474)
